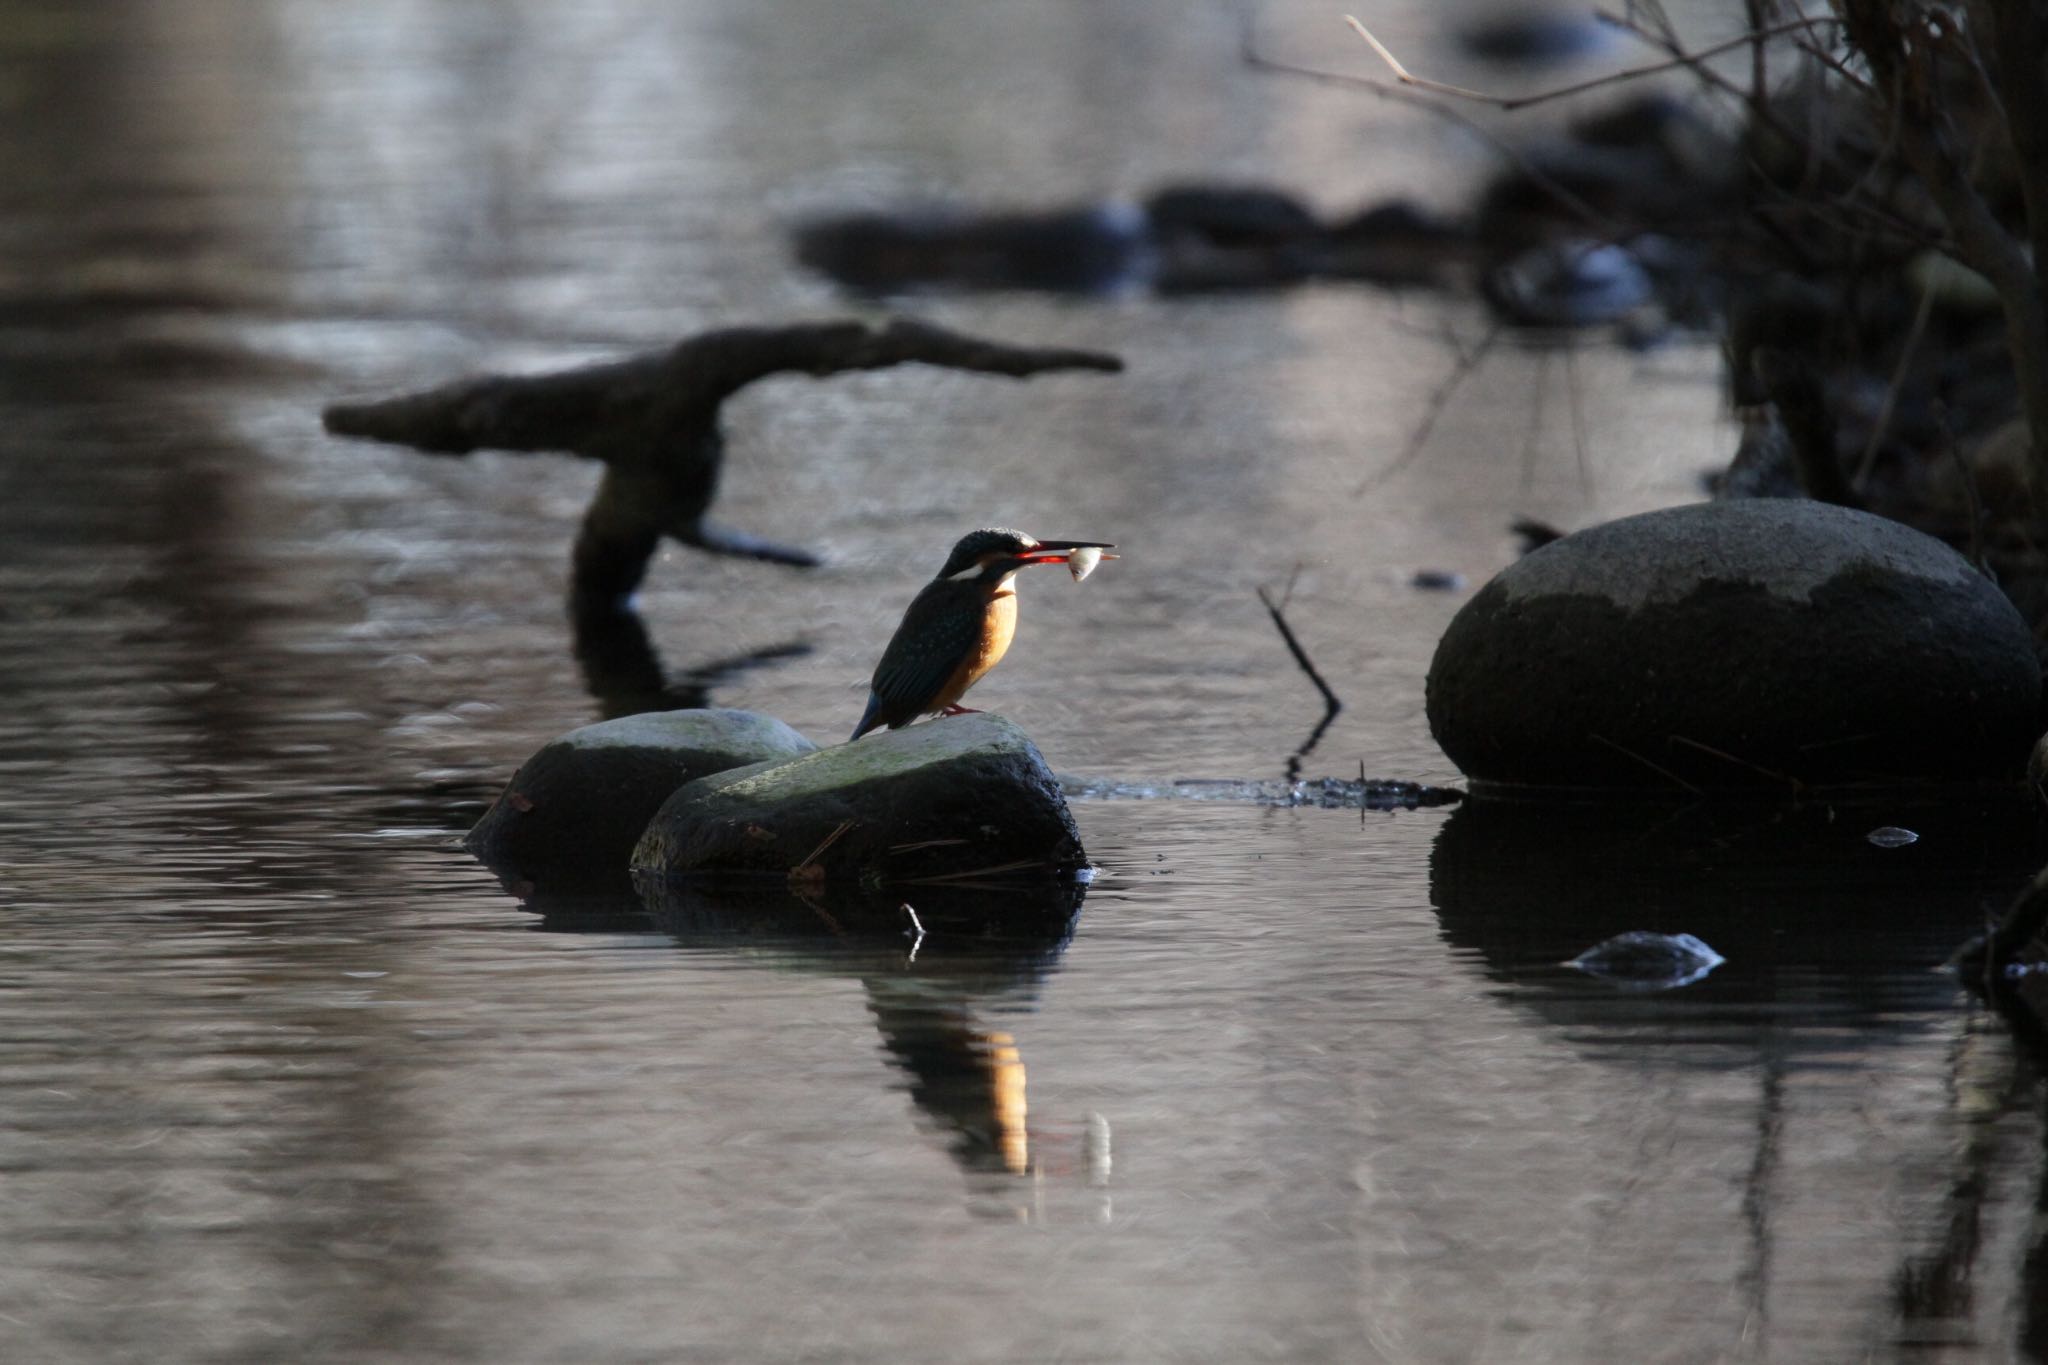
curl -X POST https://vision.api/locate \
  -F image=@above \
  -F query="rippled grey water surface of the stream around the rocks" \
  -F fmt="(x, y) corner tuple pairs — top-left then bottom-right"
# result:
(0, 0), (2048, 1361)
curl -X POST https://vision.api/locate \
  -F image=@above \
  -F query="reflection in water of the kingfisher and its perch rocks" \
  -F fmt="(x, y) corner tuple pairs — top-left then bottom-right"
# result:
(526, 878), (1108, 1212)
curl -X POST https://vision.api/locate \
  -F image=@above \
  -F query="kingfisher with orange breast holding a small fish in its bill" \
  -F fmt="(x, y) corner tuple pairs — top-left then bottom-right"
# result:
(848, 526), (1116, 743)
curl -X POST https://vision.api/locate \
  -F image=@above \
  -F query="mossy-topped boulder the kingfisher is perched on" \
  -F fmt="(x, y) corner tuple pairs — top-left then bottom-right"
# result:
(633, 712), (1087, 886)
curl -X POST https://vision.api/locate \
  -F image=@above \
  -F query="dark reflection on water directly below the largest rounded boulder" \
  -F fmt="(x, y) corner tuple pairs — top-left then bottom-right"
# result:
(1430, 798), (2048, 1025)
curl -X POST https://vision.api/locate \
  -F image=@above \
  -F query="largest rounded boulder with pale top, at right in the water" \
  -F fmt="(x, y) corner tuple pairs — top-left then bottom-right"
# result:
(1427, 499), (2042, 794)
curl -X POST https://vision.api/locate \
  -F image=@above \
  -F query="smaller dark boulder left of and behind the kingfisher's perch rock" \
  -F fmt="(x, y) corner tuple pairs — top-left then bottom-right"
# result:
(465, 708), (817, 890)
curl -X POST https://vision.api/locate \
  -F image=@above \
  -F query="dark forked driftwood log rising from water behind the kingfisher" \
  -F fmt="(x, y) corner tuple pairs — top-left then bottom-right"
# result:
(322, 319), (1122, 610)
